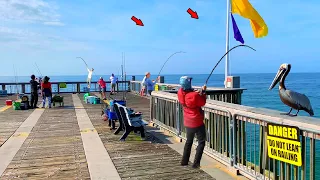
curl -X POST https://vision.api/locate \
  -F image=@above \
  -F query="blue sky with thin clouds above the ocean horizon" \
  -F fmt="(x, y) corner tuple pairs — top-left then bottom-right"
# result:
(0, 0), (320, 76)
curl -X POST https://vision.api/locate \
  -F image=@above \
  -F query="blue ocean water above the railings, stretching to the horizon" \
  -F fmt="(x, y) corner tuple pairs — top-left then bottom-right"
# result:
(0, 73), (320, 117)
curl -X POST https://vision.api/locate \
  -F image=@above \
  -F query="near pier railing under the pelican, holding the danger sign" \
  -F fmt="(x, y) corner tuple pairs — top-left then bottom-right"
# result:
(150, 91), (320, 180)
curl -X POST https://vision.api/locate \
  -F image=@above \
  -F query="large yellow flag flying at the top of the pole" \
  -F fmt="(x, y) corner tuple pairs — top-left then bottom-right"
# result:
(231, 0), (268, 38)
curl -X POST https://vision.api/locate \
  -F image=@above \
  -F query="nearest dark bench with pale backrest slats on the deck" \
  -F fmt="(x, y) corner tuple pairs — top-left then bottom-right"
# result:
(118, 104), (145, 141)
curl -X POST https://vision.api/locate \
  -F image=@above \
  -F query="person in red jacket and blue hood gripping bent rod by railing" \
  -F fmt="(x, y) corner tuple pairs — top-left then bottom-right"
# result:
(178, 76), (206, 168)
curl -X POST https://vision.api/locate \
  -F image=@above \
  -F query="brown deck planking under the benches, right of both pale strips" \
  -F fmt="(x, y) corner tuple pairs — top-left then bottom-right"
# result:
(79, 93), (214, 180)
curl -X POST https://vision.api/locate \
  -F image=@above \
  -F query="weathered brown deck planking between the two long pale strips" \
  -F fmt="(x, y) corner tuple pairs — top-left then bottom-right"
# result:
(0, 95), (90, 179)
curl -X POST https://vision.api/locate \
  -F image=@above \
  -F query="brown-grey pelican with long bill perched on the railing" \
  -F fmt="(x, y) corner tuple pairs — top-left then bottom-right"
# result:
(269, 64), (314, 116)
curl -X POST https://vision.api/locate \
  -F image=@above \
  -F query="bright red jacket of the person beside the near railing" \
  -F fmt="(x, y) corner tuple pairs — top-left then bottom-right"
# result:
(178, 88), (207, 128)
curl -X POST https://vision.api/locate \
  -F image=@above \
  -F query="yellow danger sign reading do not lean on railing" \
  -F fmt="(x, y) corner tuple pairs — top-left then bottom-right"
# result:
(267, 123), (302, 166)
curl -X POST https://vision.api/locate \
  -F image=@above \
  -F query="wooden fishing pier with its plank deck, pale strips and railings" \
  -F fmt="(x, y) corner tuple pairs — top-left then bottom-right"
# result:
(0, 79), (320, 180)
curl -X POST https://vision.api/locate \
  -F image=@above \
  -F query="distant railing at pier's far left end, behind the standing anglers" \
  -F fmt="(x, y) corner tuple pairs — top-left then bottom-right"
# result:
(0, 81), (130, 94)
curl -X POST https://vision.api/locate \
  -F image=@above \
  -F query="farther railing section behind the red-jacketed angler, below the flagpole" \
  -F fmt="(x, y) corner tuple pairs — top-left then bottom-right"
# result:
(130, 81), (245, 104)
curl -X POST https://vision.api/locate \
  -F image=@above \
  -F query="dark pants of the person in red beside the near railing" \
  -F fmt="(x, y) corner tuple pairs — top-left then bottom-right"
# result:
(181, 125), (206, 166)
